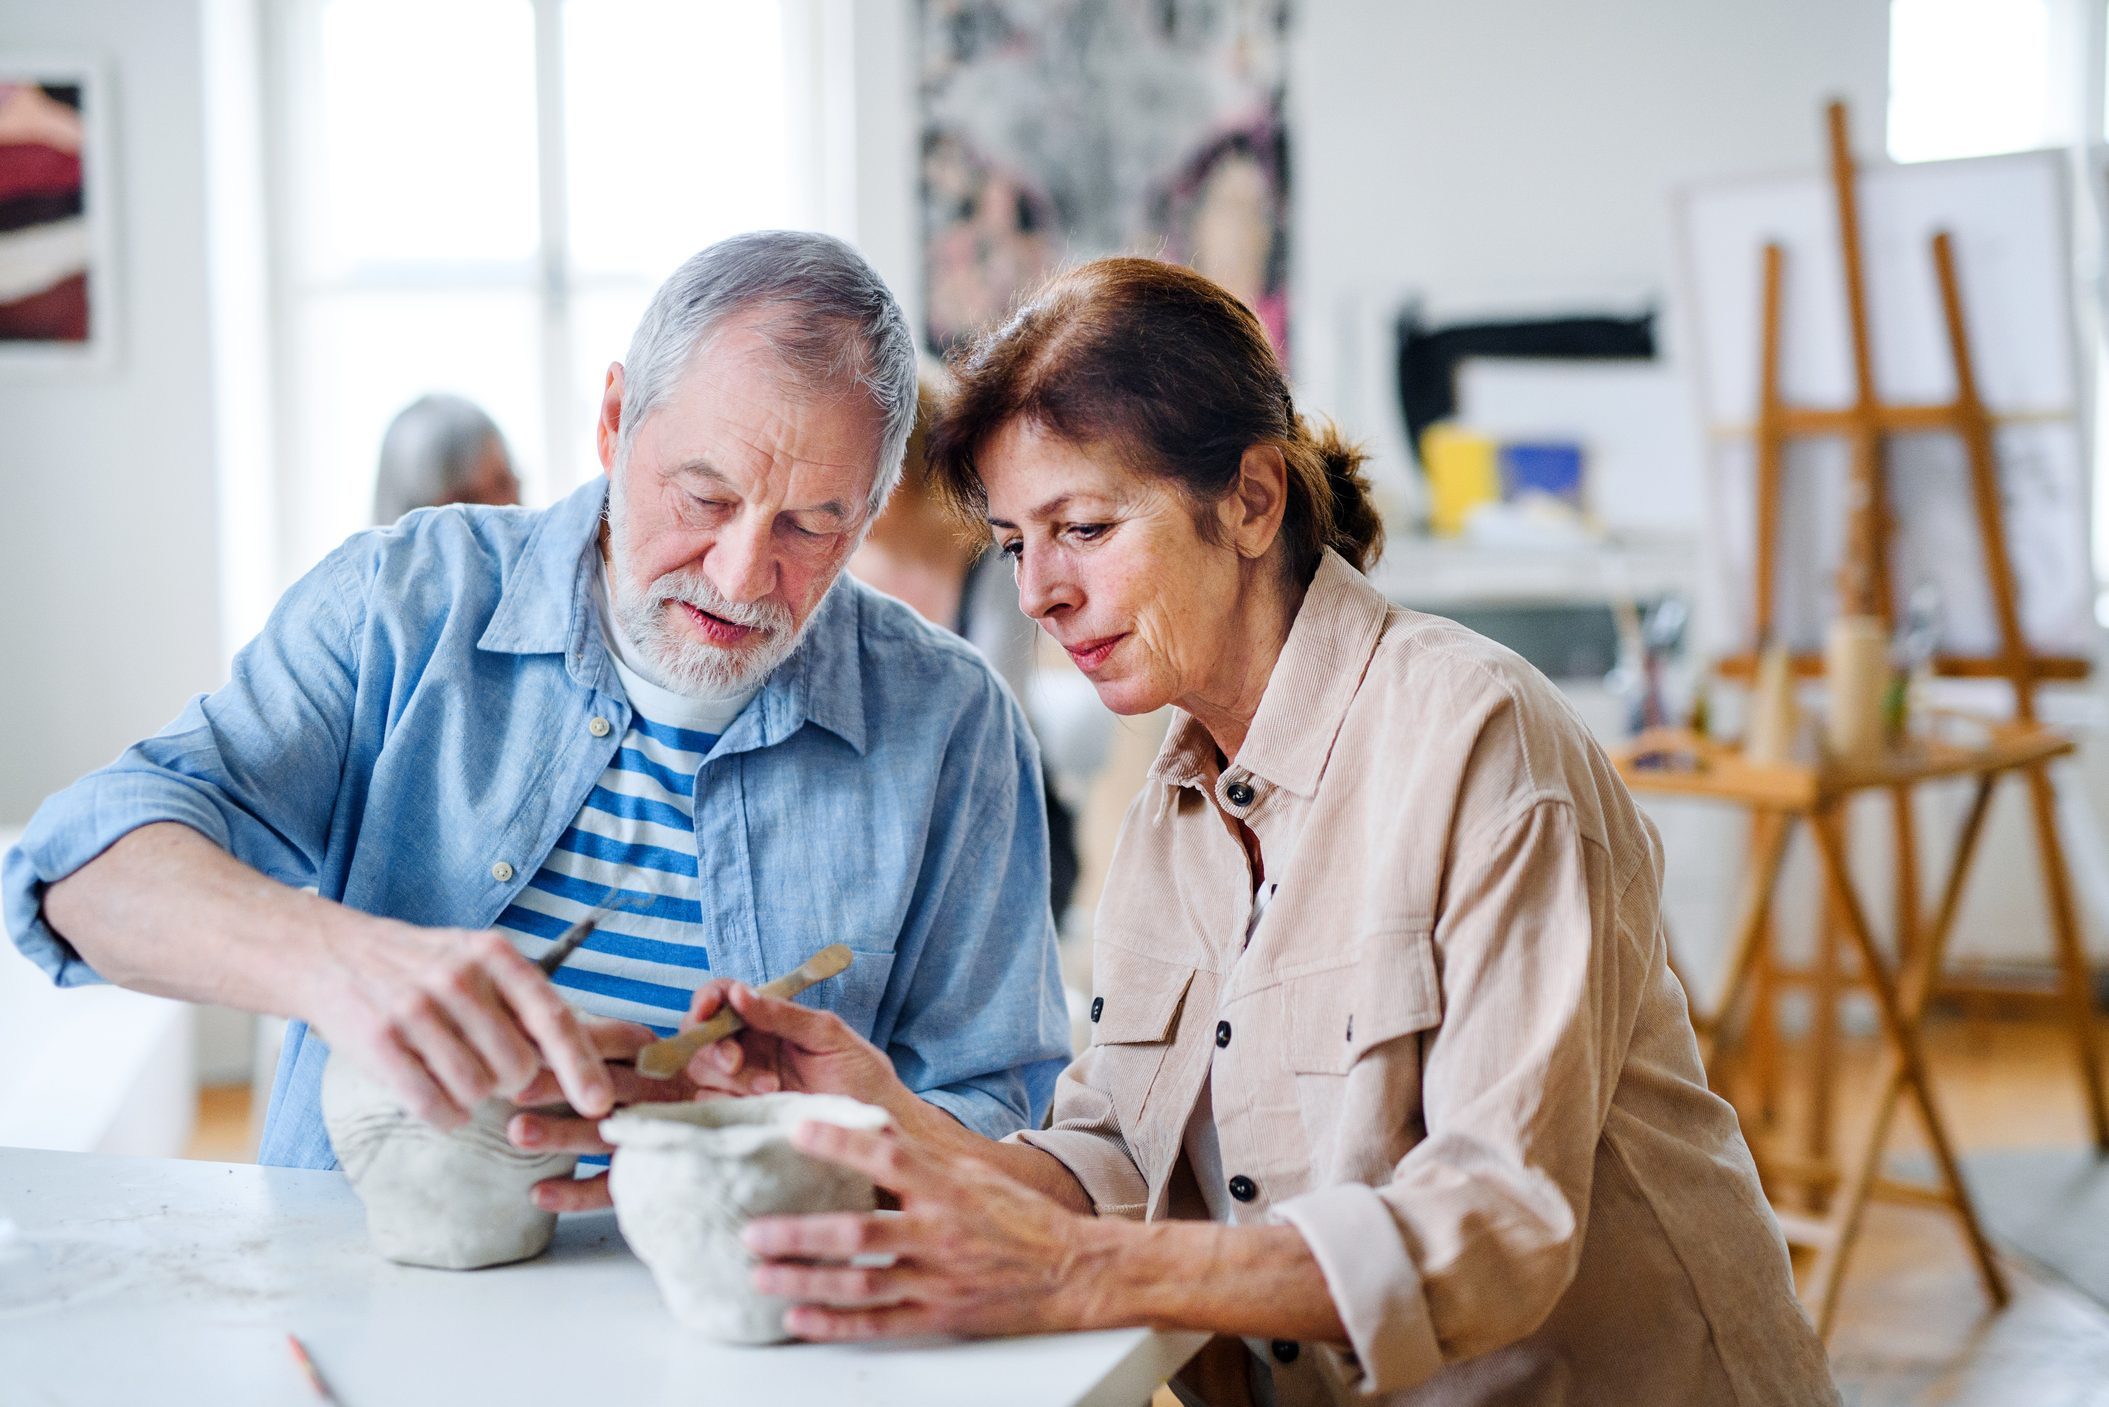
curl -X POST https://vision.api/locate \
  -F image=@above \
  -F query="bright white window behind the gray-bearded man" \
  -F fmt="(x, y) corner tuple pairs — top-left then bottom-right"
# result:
(263, 0), (823, 582)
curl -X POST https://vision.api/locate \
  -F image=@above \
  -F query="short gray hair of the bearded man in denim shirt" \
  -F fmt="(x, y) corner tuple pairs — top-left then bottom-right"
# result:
(616, 230), (915, 521)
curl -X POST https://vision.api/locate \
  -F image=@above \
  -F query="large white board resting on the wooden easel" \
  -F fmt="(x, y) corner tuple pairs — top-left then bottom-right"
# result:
(1677, 152), (2094, 656)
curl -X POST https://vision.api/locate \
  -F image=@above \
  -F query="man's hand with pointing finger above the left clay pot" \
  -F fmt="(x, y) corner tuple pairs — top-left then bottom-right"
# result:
(297, 915), (614, 1129)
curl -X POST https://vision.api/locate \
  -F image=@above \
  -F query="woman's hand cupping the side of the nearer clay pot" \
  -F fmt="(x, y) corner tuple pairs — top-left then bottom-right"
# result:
(744, 1122), (1128, 1339)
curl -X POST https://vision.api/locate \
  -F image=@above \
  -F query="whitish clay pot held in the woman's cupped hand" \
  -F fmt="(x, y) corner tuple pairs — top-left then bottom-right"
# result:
(601, 1095), (892, 1344)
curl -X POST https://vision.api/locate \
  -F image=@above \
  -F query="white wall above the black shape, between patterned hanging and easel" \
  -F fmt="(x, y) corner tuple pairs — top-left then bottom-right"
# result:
(1289, 0), (1890, 489)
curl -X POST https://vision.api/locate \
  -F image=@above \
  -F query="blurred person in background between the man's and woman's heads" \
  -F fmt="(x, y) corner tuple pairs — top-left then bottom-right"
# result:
(850, 375), (1080, 926)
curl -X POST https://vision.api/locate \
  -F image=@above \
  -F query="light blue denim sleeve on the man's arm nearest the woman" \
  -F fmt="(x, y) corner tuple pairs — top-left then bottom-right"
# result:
(886, 675), (1069, 1139)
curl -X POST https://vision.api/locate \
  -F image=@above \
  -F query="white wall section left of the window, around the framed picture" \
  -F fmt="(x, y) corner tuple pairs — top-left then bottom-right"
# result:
(0, 0), (221, 825)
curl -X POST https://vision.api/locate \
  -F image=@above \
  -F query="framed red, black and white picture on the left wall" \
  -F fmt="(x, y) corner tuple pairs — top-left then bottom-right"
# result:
(0, 51), (116, 367)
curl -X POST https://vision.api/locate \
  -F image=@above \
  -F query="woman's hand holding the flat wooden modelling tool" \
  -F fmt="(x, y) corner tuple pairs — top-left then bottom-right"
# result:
(683, 977), (928, 1129)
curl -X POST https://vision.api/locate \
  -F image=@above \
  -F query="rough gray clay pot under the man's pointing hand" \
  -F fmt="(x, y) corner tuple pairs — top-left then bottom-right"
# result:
(323, 1055), (578, 1270)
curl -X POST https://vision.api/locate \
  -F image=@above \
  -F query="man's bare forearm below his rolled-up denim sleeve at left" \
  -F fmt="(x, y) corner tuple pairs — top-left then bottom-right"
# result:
(44, 821), (345, 1017)
